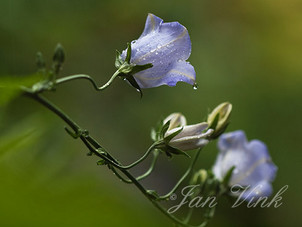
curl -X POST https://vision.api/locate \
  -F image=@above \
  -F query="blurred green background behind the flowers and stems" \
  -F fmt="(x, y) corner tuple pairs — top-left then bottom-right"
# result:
(0, 0), (302, 226)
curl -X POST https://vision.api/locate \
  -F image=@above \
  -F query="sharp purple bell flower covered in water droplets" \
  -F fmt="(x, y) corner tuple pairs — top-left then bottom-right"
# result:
(121, 14), (196, 88)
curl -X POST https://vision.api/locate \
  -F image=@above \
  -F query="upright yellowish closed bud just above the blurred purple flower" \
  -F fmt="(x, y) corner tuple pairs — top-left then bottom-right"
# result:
(207, 102), (232, 139)
